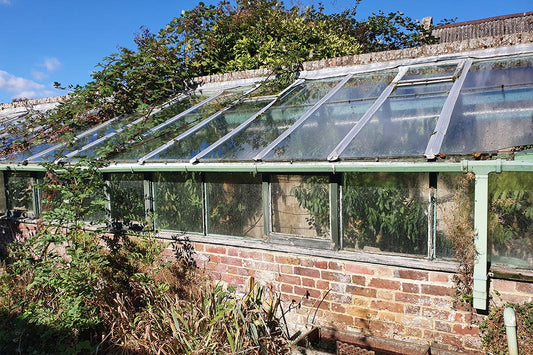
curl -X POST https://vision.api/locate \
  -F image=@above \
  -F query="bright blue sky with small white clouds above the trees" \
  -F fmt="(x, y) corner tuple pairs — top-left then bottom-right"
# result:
(0, 0), (533, 102)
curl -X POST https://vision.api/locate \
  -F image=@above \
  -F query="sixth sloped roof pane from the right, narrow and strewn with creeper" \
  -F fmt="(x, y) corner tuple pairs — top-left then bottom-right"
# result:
(110, 87), (250, 161)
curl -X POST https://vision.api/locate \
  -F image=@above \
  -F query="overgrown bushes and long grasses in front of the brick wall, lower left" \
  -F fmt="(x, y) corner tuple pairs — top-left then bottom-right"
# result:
(0, 161), (296, 354)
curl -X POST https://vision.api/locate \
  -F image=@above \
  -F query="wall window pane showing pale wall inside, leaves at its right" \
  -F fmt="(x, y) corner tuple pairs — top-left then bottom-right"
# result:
(270, 175), (330, 239)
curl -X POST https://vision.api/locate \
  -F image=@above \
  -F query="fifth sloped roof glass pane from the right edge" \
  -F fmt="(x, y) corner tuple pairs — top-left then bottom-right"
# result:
(148, 99), (272, 161)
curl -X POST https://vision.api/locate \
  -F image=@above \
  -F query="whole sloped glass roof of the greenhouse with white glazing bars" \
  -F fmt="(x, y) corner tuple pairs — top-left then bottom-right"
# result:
(0, 46), (533, 164)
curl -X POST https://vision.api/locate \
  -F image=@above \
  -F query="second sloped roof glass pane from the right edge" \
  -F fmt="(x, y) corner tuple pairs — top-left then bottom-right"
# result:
(341, 82), (452, 158)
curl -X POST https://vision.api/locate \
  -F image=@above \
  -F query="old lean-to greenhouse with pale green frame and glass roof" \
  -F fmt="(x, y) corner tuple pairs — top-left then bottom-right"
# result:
(0, 39), (533, 322)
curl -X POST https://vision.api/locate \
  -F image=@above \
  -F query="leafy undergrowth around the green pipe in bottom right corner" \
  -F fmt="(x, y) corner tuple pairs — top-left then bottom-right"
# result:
(479, 302), (533, 355)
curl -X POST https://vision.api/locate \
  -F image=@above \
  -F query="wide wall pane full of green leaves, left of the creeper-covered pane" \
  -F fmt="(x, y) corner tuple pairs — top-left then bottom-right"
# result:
(342, 173), (430, 256)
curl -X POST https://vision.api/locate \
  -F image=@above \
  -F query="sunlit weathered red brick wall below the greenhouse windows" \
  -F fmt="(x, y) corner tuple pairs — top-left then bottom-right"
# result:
(161, 243), (533, 353)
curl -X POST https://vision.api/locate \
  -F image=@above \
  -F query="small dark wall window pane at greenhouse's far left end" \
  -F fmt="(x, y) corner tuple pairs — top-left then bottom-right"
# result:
(6, 173), (34, 217)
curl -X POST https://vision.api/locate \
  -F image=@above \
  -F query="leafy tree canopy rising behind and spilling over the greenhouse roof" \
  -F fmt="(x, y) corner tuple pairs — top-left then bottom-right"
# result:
(4, 0), (435, 156)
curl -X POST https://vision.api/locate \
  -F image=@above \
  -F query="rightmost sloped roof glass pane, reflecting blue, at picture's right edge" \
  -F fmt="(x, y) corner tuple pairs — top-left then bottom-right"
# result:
(441, 56), (533, 154)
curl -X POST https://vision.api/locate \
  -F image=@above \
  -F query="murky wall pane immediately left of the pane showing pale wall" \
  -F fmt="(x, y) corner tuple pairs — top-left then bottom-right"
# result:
(206, 173), (263, 238)
